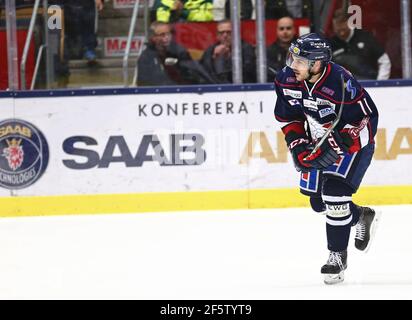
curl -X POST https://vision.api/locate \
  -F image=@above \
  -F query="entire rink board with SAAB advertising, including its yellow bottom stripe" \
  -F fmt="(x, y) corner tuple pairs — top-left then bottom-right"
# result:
(0, 86), (412, 216)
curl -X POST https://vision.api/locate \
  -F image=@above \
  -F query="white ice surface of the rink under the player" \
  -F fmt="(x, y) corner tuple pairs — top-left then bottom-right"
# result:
(0, 205), (412, 300)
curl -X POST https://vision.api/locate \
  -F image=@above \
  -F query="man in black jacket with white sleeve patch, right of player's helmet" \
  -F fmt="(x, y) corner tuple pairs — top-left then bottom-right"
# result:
(331, 9), (391, 80)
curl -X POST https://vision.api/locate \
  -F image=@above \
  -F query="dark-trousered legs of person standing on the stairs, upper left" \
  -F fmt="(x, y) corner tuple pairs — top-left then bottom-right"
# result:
(64, 0), (103, 63)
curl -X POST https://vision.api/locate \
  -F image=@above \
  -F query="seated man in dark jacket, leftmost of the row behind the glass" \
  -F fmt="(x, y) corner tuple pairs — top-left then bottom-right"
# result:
(137, 21), (212, 86)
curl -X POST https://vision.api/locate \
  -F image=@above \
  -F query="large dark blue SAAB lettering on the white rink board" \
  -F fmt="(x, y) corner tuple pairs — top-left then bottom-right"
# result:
(63, 134), (206, 170)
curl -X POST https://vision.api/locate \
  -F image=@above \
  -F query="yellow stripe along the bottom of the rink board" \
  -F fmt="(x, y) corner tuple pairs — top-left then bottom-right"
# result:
(0, 186), (412, 217)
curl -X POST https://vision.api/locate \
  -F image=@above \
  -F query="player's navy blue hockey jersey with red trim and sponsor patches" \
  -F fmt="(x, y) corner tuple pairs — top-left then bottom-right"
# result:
(275, 62), (378, 153)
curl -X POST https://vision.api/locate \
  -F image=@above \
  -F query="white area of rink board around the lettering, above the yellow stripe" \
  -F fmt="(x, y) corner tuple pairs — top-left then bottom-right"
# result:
(0, 87), (412, 196)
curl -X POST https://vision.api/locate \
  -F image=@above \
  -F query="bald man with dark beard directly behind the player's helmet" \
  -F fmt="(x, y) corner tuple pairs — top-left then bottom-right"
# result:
(266, 16), (296, 82)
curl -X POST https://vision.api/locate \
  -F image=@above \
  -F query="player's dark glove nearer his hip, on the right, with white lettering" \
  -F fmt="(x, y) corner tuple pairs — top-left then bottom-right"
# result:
(303, 132), (347, 170)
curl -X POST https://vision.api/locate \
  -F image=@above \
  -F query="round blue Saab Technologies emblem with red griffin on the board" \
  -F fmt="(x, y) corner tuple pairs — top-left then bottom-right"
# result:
(0, 119), (49, 190)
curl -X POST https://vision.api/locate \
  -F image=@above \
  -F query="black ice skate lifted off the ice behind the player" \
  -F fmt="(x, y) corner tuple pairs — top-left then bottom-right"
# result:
(355, 207), (380, 252)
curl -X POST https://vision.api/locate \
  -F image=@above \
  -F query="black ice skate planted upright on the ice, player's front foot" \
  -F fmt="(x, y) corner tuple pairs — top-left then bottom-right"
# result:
(320, 250), (348, 284)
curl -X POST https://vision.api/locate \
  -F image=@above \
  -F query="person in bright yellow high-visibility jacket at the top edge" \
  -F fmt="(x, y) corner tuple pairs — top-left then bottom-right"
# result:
(152, 0), (213, 22)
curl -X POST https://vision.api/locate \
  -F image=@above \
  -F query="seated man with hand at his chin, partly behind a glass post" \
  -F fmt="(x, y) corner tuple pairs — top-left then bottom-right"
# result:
(200, 20), (256, 83)
